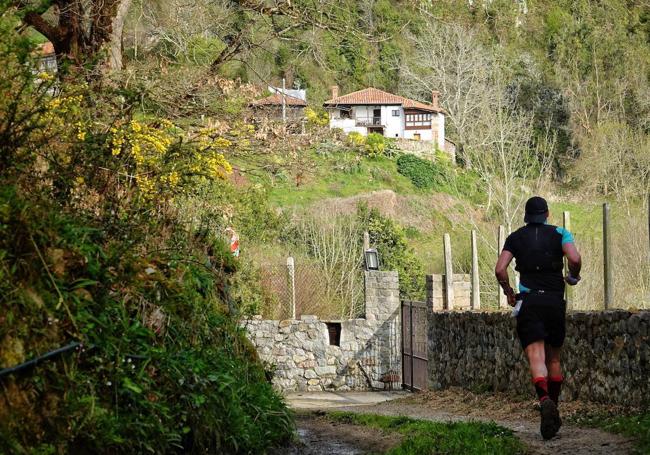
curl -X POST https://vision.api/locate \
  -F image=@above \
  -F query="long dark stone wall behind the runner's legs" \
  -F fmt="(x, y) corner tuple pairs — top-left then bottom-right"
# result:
(429, 311), (650, 405)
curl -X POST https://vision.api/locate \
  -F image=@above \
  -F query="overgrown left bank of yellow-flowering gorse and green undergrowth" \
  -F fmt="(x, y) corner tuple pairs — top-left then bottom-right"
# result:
(0, 22), (293, 453)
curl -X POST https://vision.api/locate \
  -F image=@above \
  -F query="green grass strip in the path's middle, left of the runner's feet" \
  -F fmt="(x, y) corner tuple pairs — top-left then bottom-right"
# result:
(328, 412), (526, 455)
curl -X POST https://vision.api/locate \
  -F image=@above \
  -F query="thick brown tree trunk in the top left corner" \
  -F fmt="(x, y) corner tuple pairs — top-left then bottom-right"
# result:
(13, 0), (132, 70)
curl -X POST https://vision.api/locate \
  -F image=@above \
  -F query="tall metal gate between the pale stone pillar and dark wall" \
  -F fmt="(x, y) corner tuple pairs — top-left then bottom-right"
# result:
(402, 300), (429, 391)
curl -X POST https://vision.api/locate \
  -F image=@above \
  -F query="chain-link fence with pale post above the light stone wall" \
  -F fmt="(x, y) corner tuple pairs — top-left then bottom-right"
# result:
(260, 258), (364, 319)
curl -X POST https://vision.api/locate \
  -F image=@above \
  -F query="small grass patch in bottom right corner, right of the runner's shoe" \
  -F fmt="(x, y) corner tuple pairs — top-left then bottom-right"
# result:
(571, 411), (650, 455)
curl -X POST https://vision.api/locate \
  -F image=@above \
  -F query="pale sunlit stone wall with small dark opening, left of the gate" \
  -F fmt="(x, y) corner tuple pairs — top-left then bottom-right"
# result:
(242, 271), (402, 391)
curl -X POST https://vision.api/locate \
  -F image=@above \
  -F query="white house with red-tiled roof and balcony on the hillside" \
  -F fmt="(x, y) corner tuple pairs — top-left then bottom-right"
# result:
(323, 86), (445, 150)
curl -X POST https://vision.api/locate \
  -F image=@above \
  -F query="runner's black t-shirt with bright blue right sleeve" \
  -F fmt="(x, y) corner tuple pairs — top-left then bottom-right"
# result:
(503, 223), (573, 292)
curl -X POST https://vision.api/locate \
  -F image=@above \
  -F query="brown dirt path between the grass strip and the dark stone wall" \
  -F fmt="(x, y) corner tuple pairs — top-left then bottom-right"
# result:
(339, 390), (633, 455)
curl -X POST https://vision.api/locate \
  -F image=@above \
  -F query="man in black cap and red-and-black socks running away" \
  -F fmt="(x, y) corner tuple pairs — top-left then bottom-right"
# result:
(495, 196), (581, 439)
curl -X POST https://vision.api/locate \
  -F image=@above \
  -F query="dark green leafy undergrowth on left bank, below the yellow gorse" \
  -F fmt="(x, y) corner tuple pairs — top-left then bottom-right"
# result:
(0, 186), (292, 453)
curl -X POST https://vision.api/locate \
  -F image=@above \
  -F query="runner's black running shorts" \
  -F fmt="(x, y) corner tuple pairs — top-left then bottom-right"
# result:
(517, 293), (566, 349)
